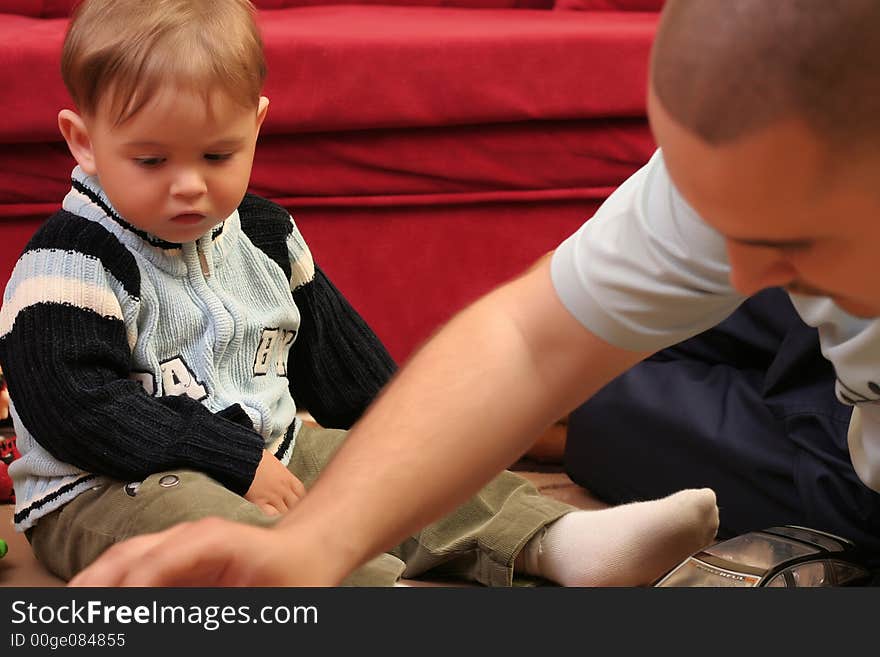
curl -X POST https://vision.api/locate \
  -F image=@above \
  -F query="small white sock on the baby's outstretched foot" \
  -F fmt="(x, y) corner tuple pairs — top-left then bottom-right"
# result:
(514, 488), (718, 586)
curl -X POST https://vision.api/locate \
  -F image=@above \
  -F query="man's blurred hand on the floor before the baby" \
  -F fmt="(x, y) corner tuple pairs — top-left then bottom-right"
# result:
(69, 518), (344, 586)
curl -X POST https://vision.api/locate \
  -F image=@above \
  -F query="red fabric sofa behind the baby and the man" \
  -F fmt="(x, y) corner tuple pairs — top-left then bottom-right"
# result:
(0, 0), (662, 361)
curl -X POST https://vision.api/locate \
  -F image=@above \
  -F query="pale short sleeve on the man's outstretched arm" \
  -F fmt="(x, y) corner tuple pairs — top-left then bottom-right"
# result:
(551, 151), (744, 351)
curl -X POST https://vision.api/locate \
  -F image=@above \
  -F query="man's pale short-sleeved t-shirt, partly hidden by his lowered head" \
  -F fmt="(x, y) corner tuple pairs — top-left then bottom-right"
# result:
(551, 150), (880, 491)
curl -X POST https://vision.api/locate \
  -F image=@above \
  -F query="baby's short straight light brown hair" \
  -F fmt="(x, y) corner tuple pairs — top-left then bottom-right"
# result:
(61, 0), (266, 125)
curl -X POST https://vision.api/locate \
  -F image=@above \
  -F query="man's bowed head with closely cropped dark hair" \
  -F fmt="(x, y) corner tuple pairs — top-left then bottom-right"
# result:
(648, 0), (880, 316)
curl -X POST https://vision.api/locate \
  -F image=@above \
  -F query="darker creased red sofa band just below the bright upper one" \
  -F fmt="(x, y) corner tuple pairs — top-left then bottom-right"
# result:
(0, 120), (654, 215)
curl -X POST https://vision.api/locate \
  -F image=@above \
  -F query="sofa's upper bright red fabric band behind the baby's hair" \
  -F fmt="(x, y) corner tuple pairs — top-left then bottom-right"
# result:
(0, 6), (656, 143)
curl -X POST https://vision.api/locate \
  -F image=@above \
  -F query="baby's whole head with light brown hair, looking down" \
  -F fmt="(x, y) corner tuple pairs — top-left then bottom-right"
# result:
(58, 0), (268, 242)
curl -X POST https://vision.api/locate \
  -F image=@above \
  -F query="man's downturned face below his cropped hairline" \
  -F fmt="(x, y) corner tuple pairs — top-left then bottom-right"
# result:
(648, 83), (880, 317)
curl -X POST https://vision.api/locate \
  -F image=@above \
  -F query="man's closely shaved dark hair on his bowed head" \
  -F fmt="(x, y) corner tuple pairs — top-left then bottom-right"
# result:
(651, 0), (880, 147)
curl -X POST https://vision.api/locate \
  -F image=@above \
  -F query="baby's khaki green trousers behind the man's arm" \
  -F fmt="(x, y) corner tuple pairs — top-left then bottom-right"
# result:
(27, 426), (574, 586)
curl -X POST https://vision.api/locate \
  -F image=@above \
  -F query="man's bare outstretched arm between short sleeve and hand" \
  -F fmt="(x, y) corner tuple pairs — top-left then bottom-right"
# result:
(280, 258), (647, 579)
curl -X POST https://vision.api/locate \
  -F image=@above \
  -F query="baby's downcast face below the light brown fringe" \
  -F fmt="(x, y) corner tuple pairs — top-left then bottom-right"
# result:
(86, 88), (268, 242)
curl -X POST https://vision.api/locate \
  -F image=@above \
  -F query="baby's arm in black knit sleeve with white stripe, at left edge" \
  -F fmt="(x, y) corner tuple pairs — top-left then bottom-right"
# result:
(0, 221), (263, 494)
